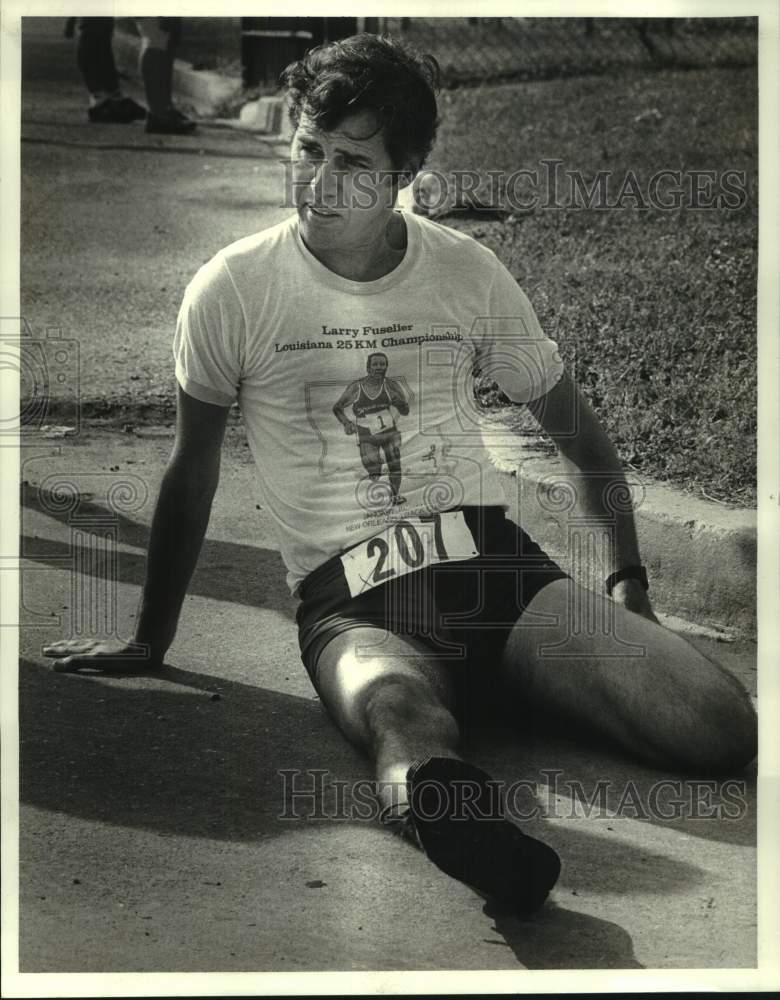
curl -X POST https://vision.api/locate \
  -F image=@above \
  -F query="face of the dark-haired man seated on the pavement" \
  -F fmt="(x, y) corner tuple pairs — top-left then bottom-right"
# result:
(290, 111), (406, 252)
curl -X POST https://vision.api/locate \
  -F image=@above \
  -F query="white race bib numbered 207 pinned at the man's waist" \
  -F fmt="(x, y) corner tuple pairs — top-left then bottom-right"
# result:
(341, 510), (479, 597)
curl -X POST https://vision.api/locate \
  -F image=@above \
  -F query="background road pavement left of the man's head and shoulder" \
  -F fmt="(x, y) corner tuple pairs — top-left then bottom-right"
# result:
(21, 18), (292, 416)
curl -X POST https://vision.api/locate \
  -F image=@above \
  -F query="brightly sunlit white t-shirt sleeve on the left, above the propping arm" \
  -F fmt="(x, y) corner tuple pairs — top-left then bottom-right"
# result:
(173, 256), (245, 406)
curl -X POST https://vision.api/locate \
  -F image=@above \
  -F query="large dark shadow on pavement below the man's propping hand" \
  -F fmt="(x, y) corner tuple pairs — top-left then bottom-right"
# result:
(19, 660), (356, 841)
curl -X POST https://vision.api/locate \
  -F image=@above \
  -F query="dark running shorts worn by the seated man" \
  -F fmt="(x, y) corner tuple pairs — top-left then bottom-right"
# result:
(296, 507), (568, 689)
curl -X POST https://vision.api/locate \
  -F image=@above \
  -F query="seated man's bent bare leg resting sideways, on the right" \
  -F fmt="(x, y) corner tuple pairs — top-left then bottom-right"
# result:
(503, 580), (757, 772)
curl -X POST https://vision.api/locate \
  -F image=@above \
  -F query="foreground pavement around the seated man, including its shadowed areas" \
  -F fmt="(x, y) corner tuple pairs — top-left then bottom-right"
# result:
(20, 426), (756, 972)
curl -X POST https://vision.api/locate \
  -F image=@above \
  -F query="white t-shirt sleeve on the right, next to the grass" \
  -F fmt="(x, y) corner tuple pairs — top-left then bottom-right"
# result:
(475, 259), (563, 403)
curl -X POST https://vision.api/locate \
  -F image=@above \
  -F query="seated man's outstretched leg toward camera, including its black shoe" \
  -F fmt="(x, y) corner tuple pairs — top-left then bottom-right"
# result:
(319, 628), (560, 913)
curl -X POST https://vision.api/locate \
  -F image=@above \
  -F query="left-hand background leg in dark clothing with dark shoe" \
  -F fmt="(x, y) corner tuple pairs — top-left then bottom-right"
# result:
(76, 17), (146, 124)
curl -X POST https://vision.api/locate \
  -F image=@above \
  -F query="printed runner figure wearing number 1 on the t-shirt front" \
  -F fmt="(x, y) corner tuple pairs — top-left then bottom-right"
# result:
(333, 352), (409, 505)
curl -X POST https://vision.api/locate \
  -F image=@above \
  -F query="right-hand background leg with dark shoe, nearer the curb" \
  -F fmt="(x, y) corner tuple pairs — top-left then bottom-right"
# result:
(136, 17), (195, 135)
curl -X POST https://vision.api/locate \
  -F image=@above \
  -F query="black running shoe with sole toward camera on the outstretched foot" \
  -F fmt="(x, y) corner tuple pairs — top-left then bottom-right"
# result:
(407, 757), (561, 916)
